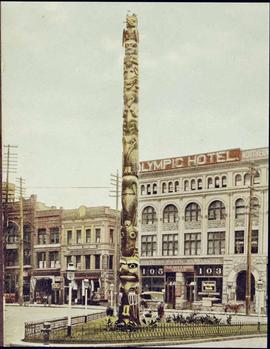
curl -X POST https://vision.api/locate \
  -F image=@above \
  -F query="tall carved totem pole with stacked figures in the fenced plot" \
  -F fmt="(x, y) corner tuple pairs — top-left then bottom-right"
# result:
(118, 14), (140, 325)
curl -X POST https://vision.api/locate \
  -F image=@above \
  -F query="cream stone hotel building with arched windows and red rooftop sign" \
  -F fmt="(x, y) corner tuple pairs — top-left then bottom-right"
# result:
(138, 148), (268, 311)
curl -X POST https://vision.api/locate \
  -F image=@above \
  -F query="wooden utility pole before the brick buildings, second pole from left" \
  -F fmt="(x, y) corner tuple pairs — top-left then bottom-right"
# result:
(18, 177), (24, 305)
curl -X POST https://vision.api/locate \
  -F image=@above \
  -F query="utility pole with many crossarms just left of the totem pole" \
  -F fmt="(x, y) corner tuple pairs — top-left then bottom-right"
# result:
(110, 170), (121, 313)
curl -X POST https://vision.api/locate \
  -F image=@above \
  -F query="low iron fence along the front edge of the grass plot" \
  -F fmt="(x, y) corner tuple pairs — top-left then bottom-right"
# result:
(25, 318), (267, 344)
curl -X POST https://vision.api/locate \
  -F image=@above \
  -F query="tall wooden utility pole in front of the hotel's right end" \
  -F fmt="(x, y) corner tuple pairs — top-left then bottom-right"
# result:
(246, 165), (257, 315)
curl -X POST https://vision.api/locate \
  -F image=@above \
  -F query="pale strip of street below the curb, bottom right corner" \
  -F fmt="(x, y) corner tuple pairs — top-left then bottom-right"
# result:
(157, 337), (267, 348)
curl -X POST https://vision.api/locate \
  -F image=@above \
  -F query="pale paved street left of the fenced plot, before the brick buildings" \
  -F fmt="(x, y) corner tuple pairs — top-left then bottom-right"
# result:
(4, 305), (104, 346)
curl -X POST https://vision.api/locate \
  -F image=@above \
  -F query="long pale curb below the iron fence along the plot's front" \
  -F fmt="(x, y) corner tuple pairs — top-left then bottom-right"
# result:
(9, 334), (267, 348)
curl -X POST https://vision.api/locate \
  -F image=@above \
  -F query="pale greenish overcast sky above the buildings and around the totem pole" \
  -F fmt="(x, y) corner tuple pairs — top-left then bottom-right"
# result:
(2, 2), (269, 208)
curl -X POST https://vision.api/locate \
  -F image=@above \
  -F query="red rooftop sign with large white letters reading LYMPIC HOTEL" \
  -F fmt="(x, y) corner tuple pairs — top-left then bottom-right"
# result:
(140, 148), (241, 172)
